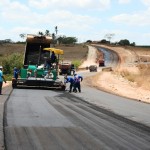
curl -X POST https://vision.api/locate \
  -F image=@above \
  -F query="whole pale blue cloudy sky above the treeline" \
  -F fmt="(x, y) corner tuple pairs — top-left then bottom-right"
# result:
(0, 0), (150, 45)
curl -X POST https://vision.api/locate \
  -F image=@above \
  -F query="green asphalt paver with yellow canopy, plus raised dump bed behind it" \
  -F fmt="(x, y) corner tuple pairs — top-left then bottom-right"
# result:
(12, 35), (65, 90)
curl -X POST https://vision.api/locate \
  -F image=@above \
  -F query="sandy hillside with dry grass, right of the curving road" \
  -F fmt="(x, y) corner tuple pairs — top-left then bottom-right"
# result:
(84, 45), (150, 103)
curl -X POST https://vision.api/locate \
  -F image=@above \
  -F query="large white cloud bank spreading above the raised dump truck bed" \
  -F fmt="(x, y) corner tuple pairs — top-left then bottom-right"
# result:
(0, 7), (101, 41)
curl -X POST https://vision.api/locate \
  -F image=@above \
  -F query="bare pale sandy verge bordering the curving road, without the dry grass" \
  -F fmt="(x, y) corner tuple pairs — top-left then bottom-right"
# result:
(84, 46), (150, 103)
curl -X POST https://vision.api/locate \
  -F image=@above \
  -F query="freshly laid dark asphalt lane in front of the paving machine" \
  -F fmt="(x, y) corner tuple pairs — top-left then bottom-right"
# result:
(4, 87), (150, 150)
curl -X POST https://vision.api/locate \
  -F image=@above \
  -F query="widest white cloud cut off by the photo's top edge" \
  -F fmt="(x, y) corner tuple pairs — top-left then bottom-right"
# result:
(29, 0), (110, 10)
